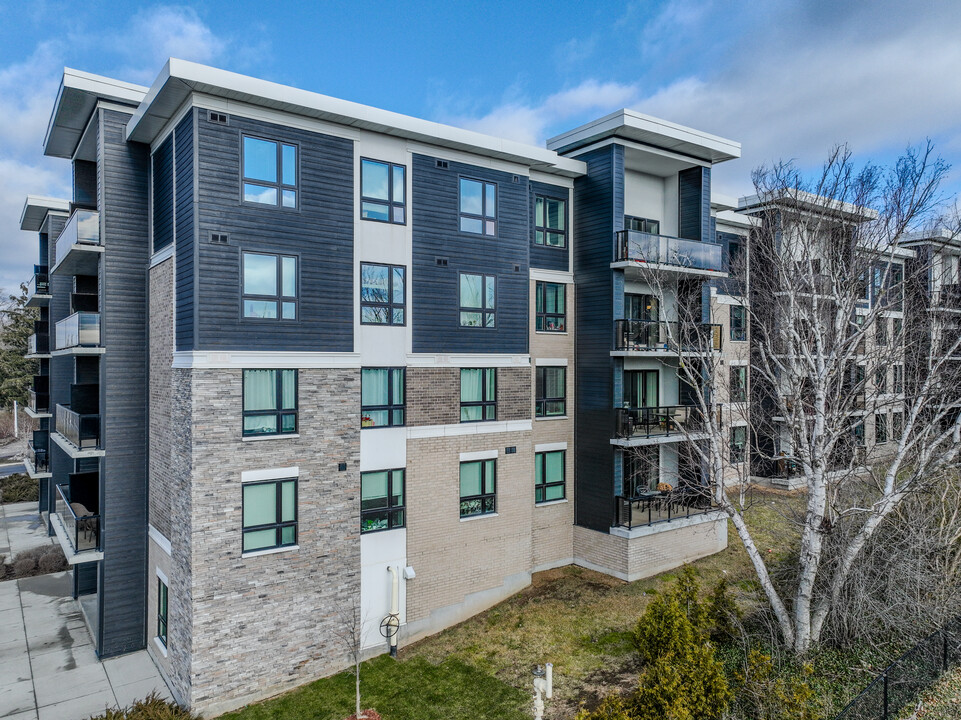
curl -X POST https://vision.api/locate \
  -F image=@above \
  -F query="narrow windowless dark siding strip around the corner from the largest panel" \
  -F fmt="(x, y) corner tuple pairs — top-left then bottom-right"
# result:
(174, 110), (197, 350)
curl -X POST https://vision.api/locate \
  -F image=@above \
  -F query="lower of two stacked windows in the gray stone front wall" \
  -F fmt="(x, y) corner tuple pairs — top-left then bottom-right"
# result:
(243, 478), (297, 552)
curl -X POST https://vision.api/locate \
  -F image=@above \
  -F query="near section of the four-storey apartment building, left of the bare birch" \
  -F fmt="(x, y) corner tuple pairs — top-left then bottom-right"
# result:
(21, 59), (749, 713)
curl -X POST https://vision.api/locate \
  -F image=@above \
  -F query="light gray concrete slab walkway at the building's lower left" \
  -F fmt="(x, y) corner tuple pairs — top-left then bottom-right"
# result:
(0, 506), (170, 720)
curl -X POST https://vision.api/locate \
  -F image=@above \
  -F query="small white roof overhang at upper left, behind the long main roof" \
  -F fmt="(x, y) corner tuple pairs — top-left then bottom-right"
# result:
(43, 68), (147, 159)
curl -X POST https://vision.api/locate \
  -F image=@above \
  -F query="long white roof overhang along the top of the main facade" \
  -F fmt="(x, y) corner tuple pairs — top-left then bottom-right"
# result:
(127, 58), (587, 177)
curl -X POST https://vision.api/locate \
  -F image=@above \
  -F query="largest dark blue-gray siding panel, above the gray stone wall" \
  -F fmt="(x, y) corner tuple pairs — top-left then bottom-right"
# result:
(191, 110), (354, 352)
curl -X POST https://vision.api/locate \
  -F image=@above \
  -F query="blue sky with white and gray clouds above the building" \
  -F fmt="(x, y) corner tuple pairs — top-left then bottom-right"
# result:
(0, 0), (961, 292)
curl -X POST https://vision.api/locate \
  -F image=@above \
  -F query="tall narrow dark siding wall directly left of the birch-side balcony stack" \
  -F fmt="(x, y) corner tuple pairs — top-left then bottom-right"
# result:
(574, 145), (624, 531)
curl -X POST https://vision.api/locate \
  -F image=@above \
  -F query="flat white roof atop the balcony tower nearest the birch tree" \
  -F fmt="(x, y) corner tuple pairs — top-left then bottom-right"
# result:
(547, 108), (741, 163)
